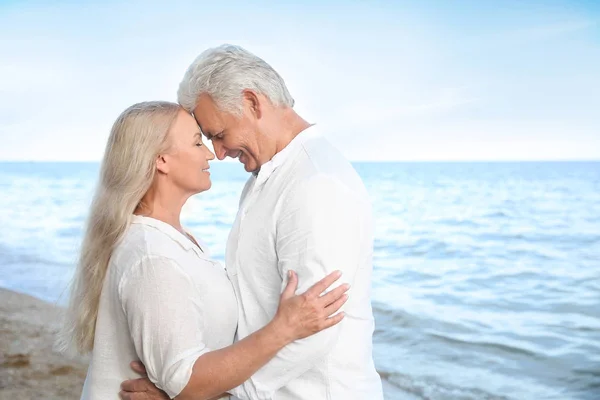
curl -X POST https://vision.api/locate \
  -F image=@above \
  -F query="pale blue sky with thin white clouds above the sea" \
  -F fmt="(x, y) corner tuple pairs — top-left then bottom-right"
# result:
(0, 0), (600, 161)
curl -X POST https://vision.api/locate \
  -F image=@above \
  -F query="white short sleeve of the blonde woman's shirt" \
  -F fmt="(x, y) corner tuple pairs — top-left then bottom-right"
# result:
(119, 256), (210, 398)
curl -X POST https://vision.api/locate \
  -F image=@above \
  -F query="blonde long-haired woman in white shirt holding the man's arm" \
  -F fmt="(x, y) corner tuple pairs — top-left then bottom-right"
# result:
(62, 102), (348, 400)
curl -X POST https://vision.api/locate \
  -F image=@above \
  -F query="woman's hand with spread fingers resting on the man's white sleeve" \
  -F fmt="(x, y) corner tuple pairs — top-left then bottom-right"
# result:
(271, 271), (350, 343)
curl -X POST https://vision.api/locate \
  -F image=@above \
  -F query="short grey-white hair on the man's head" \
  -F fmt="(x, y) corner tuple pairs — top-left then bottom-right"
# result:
(177, 44), (294, 115)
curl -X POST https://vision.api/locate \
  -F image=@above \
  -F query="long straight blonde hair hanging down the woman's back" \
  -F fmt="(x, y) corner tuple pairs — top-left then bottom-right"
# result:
(58, 101), (182, 354)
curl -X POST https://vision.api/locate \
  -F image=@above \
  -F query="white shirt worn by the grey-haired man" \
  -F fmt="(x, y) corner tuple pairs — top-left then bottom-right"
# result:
(226, 127), (383, 400)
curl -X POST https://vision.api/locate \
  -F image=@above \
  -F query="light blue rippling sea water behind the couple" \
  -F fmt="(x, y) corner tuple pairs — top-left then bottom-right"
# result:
(0, 162), (600, 400)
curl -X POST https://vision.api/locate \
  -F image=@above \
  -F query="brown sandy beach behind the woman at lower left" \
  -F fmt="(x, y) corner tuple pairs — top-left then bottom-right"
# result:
(0, 288), (87, 400)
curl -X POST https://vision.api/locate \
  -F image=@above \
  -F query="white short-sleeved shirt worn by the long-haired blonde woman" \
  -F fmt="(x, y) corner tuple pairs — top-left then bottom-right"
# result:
(81, 216), (237, 400)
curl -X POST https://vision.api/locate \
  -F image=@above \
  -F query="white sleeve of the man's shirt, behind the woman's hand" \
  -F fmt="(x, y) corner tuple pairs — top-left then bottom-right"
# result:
(231, 176), (370, 400)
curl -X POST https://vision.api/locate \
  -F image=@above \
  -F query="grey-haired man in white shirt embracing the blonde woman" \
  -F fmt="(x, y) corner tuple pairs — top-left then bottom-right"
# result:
(123, 45), (383, 400)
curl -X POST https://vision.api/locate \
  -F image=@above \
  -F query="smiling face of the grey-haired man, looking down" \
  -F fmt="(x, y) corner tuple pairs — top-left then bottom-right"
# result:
(194, 94), (261, 172)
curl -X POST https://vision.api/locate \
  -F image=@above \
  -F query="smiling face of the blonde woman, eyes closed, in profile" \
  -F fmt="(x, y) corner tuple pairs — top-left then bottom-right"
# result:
(158, 109), (215, 194)
